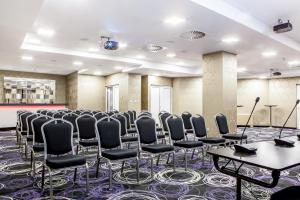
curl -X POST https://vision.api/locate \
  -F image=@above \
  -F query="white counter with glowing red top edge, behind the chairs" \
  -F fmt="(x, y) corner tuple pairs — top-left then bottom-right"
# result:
(0, 104), (66, 128)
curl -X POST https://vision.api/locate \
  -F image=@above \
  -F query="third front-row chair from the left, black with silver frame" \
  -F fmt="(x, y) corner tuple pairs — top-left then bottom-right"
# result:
(135, 116), (175, 178)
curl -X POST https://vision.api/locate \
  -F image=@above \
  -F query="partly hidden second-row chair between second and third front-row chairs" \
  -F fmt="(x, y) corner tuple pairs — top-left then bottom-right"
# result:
(112, 114), (138, 145)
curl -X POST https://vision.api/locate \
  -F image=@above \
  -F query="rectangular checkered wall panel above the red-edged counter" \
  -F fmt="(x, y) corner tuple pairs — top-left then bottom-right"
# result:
(4, 77), (55, 104)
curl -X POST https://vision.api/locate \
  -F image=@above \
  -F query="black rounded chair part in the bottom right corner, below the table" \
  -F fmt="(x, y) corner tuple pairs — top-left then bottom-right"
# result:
(270, 186), (300, 200)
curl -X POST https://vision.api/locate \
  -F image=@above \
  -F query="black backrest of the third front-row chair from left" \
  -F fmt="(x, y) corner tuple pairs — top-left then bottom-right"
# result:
(135, 117), (157, 144)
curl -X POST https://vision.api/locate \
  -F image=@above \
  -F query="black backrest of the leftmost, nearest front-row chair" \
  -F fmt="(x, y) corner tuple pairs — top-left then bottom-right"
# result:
(42, 119), (74, 155)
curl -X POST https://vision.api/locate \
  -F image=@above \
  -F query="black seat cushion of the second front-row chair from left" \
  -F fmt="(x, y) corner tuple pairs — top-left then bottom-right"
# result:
(102, 149), (137, 160)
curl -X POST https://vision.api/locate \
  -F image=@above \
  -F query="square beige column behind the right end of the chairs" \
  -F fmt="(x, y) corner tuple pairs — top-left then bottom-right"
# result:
(203, 52), (237, 135)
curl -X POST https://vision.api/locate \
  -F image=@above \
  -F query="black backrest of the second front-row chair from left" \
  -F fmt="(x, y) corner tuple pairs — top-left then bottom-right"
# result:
(96, 117), (121, 149)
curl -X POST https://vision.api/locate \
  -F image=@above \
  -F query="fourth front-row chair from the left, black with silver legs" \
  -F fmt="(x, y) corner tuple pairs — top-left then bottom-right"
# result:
(166, 115), (203, 170)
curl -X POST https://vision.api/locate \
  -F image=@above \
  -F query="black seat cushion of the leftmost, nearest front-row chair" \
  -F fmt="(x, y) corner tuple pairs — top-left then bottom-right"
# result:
(46, 155), (86, 169)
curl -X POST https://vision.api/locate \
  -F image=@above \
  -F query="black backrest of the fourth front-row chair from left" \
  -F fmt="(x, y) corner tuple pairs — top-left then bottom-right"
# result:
(166, 116), (184, 141)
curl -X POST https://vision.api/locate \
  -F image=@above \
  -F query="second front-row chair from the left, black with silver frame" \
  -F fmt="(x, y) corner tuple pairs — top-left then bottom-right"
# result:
(95, 117), (139, 189)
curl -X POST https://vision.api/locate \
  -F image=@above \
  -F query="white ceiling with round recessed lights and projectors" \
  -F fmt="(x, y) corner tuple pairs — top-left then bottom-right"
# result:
(0, 0), (300, 77)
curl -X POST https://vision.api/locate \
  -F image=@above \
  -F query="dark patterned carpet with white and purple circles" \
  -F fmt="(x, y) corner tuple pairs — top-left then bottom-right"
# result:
(0, 128), (300, 200)
